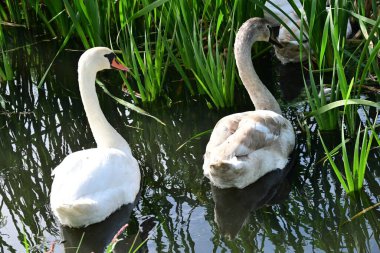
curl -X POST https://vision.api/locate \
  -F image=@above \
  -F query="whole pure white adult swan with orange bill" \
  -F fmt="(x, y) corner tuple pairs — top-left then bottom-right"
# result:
(50, 47), (140, 227)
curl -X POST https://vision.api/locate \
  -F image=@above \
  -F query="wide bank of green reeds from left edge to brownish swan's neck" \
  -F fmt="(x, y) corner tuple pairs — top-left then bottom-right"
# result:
(0, 0), (264, 108)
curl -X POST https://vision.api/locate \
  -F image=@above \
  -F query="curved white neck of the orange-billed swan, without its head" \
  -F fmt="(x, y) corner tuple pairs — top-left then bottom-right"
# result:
(78, 67), (131, 153)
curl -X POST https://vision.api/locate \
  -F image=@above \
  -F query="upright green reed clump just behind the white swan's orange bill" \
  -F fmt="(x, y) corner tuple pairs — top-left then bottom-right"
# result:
(118, 0), (172, 102)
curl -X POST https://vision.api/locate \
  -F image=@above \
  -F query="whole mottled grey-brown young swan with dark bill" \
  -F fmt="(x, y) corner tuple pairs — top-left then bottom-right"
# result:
(203, 18), (295, 188)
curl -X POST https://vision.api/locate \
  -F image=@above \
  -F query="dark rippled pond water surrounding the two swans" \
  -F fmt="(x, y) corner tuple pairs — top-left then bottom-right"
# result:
(0, 45), (380, 252)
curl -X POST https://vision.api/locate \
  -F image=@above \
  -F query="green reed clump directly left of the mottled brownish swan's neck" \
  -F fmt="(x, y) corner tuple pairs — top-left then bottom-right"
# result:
(168, 1), (263, 108)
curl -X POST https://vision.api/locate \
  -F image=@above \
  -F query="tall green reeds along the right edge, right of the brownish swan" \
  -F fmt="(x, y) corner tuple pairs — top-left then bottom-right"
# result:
(262, 0), (380, 192)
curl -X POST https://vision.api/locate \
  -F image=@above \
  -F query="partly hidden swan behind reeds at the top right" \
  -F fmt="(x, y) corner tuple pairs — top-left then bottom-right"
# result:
(264, 0), (352, 64)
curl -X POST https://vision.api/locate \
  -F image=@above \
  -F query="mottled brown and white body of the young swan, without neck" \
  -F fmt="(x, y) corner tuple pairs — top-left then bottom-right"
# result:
(203, 110), (295, 188)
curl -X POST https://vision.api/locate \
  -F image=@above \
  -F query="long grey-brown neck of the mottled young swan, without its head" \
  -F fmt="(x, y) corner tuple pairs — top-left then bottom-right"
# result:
(234, 31), (282, 115)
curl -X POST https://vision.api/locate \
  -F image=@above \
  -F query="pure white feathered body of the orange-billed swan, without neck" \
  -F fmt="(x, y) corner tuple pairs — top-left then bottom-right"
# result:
(51, 148), (140, 227)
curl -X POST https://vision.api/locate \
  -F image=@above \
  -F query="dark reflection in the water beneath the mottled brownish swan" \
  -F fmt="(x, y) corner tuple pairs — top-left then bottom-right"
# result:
(211, 163), (293, 240)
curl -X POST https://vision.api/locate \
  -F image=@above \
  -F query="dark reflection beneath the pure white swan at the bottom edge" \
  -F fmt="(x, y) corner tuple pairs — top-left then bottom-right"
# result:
(61, 198), (156, 253)
